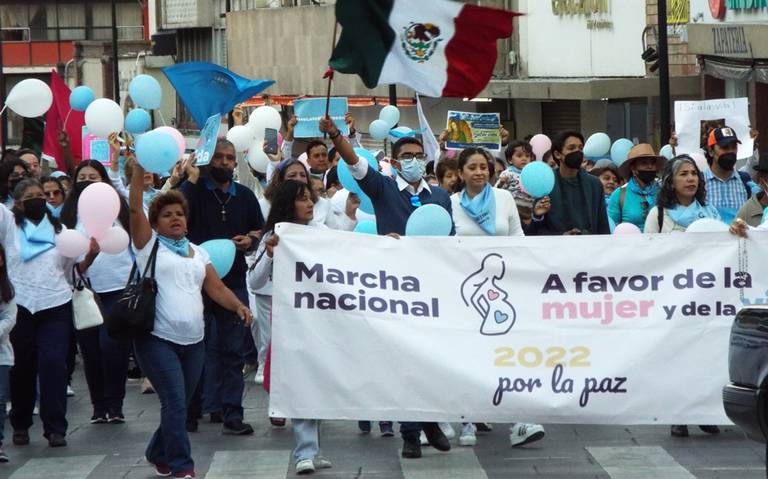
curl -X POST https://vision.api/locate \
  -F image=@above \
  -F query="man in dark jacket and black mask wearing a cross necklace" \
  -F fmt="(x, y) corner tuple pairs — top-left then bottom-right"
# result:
(181, 139), (264, 435)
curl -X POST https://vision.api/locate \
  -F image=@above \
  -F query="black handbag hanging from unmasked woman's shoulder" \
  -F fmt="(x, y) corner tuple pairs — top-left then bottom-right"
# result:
(104, 240), (159, 340)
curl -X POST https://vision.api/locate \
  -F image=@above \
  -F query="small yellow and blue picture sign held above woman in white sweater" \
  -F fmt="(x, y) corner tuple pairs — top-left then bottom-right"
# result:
(445, 111), (501, 151)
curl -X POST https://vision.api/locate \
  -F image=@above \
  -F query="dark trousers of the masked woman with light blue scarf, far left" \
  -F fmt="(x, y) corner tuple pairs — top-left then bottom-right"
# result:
(10, 303), (74, 437)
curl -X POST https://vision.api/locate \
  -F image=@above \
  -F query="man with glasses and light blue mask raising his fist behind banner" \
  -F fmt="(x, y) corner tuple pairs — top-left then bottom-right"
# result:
(320, 117), (454, 459)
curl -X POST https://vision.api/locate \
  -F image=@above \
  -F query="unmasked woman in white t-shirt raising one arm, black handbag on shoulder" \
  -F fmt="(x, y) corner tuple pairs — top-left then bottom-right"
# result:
(130, 162), (252, 479)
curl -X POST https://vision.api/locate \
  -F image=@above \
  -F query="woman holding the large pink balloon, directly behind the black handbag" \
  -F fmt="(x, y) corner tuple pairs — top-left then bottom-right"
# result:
(61, 160), (133, 424)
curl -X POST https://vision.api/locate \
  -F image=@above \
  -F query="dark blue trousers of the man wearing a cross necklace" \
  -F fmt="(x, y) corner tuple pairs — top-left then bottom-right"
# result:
(201, 288), (251, 422)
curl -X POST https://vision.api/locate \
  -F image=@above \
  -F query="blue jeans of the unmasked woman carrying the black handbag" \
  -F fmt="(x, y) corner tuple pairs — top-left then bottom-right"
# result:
(134, 335), (205, 474)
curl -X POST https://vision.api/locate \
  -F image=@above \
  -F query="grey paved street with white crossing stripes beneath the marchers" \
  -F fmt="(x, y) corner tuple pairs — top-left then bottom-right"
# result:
(0, 367), (765, 479)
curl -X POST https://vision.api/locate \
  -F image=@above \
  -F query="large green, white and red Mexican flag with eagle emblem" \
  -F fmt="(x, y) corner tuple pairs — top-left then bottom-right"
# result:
(330, 0), (518, 98)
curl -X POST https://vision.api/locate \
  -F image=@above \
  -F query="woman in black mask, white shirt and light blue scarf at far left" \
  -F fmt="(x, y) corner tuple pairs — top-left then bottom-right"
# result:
(0, 179), (95, 447)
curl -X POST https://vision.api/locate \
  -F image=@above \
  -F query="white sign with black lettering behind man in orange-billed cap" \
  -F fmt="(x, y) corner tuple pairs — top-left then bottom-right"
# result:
(675, 98), (754, 159)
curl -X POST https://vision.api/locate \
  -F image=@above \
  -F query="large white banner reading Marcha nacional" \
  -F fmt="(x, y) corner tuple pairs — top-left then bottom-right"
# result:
(270, 224), (768, 424)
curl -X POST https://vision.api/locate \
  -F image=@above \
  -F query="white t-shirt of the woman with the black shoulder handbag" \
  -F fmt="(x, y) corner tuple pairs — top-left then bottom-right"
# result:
(134, 232), (211, 346)
